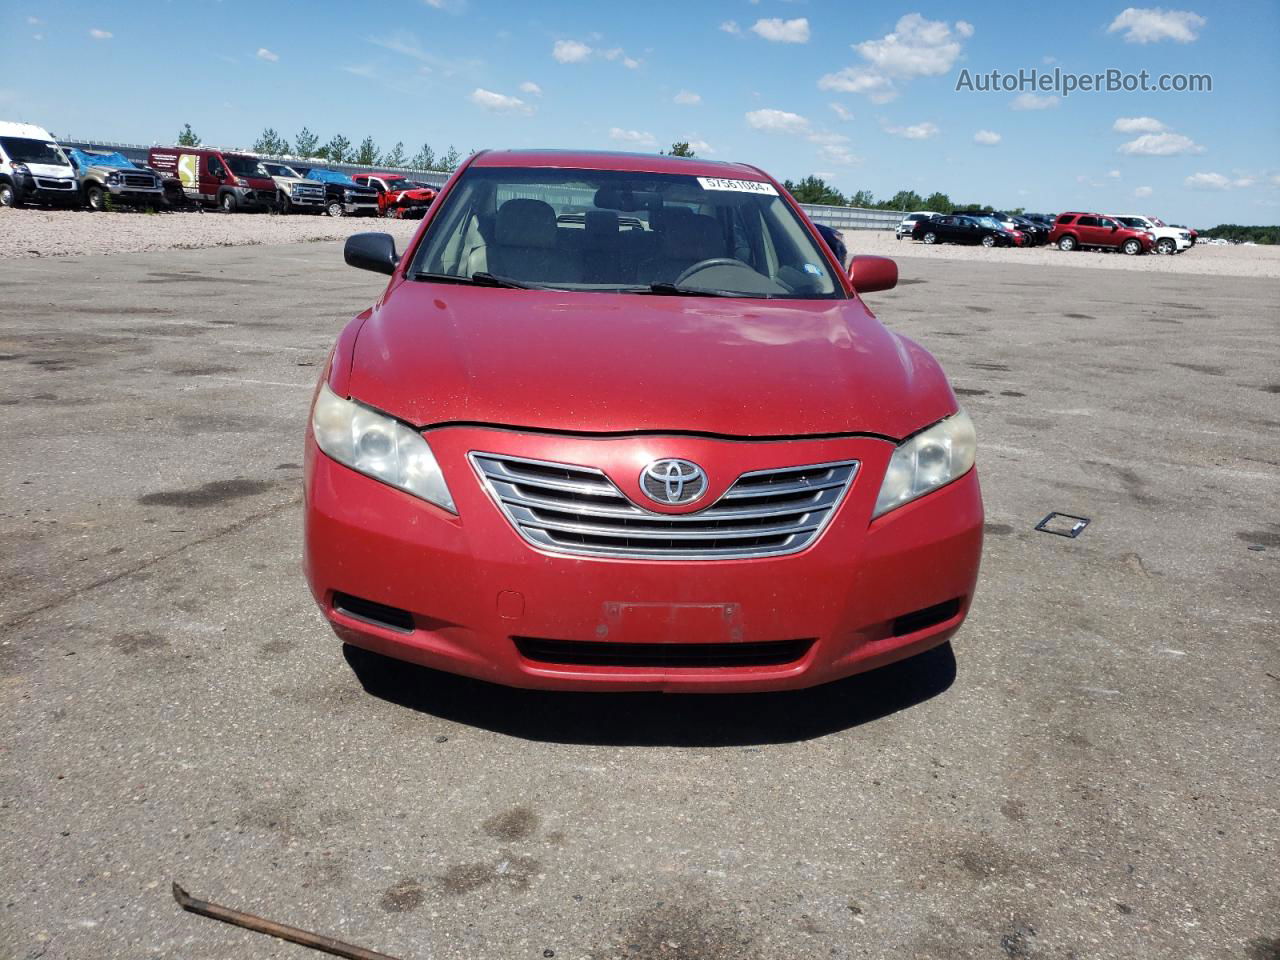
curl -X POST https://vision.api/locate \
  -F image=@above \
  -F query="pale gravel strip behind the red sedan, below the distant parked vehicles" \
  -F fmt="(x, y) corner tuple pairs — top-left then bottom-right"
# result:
(0, 210), (1280, 279)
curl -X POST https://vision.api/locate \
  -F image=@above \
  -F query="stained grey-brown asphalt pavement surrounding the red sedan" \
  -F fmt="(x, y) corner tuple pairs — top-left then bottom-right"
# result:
(0, 241), (1280, 960)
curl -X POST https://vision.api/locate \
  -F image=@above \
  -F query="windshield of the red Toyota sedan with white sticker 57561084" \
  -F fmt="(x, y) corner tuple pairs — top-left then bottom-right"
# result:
(410, 168), (845, 300)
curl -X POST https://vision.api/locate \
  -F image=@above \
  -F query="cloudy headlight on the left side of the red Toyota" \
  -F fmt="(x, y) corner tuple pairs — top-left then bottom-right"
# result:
(311, 384), (458, 513)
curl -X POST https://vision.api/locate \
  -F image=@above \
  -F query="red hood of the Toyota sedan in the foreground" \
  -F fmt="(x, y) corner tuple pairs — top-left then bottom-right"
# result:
(345, 280), (956, 439)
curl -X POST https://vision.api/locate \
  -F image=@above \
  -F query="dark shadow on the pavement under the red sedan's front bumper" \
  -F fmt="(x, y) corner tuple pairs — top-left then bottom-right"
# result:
(343, 643), (956, 746)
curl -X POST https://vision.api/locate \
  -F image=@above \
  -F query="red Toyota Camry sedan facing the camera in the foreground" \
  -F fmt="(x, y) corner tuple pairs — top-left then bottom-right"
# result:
(306, 151), (983, 691)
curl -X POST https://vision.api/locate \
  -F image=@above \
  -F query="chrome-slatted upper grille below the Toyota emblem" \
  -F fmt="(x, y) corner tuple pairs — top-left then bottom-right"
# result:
(471, 453), (858, 559)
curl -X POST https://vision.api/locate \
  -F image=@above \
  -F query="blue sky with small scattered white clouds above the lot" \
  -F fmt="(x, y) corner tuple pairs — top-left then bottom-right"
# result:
(10, 0), (1280, 227)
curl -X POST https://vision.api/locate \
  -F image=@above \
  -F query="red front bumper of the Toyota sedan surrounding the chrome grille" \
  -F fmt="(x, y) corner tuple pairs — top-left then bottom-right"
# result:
(305, 426), (983, 692)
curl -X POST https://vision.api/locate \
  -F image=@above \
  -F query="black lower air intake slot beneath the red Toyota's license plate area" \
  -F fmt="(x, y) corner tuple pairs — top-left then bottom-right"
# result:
(512, 636), (813, 668)
